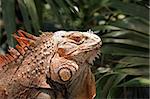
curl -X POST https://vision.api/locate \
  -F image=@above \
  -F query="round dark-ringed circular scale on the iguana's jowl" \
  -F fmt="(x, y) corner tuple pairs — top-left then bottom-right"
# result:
(58, 68), (72, 82)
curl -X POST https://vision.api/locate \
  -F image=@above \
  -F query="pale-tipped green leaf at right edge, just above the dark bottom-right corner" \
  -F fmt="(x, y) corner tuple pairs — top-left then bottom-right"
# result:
(117, 77), (150, 87)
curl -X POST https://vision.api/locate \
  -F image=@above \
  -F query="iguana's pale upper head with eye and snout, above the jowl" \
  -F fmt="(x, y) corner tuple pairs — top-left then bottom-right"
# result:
(52, 31), (102, 63)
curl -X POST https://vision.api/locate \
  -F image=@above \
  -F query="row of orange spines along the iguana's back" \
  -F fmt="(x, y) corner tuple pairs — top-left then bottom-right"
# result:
(0, 30), (38, 70)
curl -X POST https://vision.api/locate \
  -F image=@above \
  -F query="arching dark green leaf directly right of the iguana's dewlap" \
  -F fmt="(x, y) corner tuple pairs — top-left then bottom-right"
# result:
(96, 72), (126, 99)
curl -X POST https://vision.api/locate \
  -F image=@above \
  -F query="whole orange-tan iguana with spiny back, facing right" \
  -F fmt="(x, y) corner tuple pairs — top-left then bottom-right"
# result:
(0, 30), (102, 99)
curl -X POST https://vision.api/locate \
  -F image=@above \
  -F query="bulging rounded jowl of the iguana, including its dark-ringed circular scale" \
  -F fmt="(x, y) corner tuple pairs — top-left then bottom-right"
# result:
(49, 54), (79, 84)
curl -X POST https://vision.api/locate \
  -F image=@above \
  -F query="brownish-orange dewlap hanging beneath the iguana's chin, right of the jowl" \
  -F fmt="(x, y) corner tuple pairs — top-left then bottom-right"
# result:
(67, 63), (96, 99)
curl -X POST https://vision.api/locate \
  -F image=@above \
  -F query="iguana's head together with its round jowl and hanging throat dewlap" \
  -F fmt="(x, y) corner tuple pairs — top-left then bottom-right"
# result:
(47, 31), (102, 99)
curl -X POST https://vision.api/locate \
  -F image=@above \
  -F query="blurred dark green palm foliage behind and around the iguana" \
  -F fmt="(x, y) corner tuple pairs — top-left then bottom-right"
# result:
(0, 0), (150, 99)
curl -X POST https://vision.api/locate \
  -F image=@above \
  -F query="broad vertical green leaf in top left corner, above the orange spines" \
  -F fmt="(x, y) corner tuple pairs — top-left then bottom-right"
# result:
(2, 0), (16, 46)
